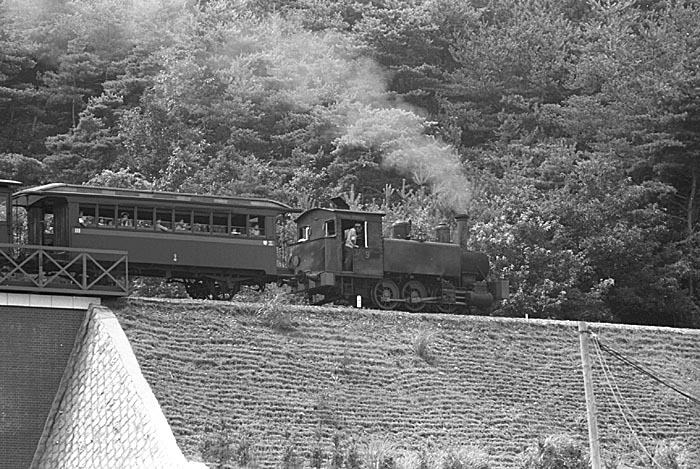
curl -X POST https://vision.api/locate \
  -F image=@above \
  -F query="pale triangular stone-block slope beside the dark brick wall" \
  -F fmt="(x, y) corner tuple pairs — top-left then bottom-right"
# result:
(31, 306), (206, 469)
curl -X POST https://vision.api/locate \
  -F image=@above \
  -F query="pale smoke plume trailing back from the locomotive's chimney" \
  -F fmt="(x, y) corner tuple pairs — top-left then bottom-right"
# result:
(206, 13), (472, 212)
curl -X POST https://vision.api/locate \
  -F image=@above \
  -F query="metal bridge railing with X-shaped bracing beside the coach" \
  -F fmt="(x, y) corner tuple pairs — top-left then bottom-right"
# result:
(0, 243), (129, 296)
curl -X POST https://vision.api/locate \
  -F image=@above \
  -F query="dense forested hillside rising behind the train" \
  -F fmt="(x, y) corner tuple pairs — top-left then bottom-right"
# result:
(0, 0), (700, 327)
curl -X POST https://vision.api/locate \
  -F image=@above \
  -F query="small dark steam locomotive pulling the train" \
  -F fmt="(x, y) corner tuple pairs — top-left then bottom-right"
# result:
(289, 208), (508, 313)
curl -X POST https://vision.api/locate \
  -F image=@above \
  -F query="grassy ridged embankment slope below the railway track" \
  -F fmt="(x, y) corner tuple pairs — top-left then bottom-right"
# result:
(111, 300), (700, 468)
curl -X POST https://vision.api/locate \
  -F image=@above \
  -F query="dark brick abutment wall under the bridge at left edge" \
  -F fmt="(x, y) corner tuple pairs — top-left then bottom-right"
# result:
(0, 306), (85, 469)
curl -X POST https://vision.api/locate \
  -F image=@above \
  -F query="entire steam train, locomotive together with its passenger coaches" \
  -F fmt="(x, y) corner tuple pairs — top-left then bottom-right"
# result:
(0, 180), (507, 312)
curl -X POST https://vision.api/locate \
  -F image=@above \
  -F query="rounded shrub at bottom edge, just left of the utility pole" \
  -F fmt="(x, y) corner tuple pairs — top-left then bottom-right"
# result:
(518, 435), (588, 469)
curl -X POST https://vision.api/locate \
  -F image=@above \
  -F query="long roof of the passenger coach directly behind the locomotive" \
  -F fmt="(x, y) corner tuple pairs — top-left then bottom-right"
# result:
(14, 183), (301, 213)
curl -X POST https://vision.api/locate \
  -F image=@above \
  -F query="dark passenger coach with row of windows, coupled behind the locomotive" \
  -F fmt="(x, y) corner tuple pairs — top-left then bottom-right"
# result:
(13, 184), (298, 299)
